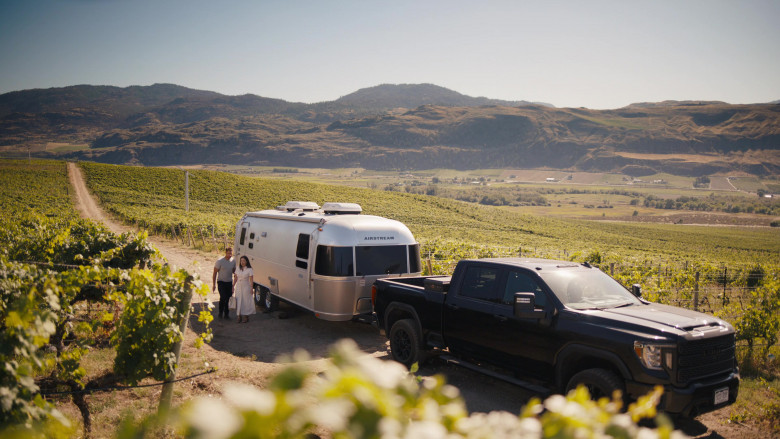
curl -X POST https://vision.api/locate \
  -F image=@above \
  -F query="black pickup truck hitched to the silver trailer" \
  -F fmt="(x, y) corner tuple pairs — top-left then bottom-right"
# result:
(373, 258), (739, 416)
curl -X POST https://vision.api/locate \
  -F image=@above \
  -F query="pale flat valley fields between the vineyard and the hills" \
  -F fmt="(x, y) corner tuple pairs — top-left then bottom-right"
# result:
(181, 165), (780, 226)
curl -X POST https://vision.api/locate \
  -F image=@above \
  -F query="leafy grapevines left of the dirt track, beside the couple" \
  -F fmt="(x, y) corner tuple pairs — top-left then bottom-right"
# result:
(0, 161), (211, 437)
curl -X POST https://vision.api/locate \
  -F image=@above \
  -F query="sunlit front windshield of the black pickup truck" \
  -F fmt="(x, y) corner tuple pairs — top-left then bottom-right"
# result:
(539, 268), (642, 309)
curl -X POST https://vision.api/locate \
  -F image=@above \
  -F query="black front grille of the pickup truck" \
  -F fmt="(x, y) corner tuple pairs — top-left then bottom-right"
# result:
(677, 334), (735, 384)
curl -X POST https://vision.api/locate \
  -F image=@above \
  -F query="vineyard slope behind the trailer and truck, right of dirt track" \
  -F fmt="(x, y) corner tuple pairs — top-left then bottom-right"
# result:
(81, 163), (780, 360)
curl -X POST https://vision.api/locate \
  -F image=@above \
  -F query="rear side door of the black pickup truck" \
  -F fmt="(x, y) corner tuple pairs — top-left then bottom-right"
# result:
(443, 264), (503, 358)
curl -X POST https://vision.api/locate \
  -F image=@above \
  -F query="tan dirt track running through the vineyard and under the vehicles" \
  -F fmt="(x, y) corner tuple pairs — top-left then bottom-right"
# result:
(68, 163), (756, 439)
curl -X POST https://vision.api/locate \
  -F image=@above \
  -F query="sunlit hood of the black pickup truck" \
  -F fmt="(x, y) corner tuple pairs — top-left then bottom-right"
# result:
(588, 303), (733, 336)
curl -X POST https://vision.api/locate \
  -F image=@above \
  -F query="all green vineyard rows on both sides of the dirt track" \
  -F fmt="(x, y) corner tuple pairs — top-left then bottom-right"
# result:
(0, 161), (780, 436)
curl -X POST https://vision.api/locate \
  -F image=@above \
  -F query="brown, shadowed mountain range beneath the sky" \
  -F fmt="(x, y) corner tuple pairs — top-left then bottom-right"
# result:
(0, 84), (780, 176)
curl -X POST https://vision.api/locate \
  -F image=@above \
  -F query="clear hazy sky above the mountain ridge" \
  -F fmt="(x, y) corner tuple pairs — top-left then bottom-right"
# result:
(0, 0), (780, 109)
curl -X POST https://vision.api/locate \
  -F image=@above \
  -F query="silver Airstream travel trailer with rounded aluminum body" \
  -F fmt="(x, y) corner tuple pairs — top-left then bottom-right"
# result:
(233, 201), (421, 320)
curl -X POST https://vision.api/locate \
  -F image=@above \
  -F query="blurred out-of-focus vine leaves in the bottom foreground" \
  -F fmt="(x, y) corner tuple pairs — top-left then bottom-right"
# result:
(119, 340), (681, 438)
